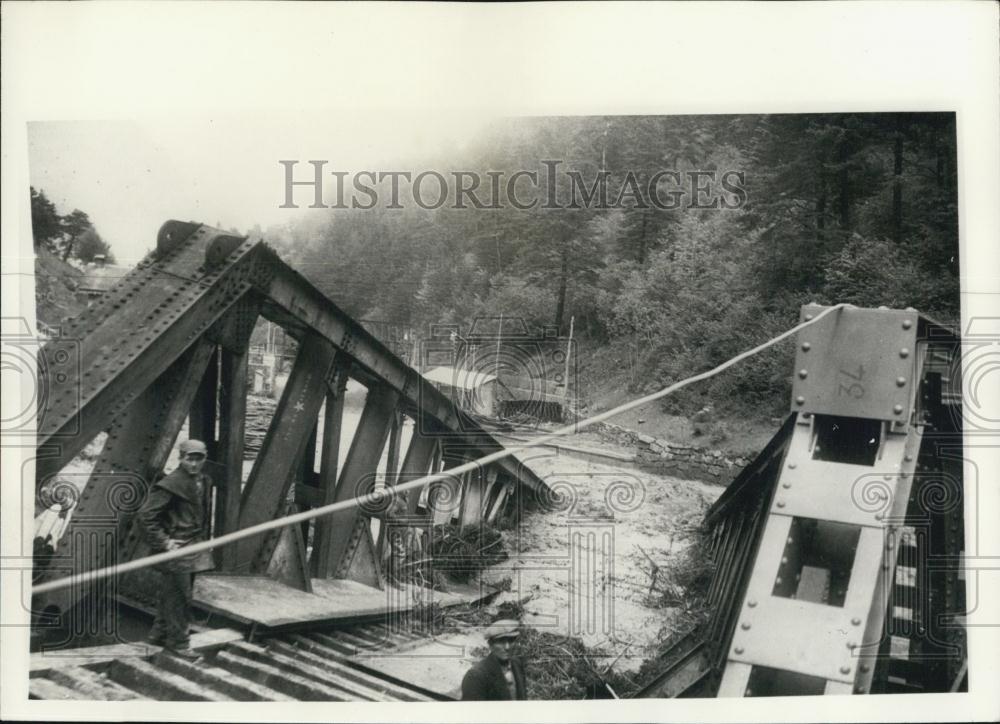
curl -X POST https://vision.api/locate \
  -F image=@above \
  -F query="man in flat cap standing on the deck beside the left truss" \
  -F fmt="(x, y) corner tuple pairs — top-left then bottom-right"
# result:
(137, 440), (212, 659)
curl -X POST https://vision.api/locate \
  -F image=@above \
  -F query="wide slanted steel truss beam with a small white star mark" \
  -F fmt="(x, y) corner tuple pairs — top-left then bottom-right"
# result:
(234, 335), (334, 571)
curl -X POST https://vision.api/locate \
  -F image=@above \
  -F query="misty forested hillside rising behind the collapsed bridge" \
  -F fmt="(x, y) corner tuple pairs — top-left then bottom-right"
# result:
(269, 114), (959, 414)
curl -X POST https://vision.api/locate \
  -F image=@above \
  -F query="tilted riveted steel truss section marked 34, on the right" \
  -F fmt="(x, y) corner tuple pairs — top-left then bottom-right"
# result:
(706, 305), (962, 697)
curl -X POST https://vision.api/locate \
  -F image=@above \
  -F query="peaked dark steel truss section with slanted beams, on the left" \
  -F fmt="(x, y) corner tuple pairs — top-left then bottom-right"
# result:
(36, 221), (544, 624)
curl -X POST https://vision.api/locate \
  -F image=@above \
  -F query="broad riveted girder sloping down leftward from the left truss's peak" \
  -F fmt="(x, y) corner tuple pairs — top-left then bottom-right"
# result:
(36, 227), (269, 484)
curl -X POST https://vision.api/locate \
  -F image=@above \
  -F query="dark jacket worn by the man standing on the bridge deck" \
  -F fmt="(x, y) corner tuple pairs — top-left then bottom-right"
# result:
(138, 467), (212, 572)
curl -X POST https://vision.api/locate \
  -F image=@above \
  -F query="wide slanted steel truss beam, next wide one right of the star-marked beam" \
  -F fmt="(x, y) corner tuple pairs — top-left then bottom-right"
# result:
(327, 386), (399, 577)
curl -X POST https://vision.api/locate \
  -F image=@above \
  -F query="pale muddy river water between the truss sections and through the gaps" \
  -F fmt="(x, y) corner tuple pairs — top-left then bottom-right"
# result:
(36, 389), (722, 686)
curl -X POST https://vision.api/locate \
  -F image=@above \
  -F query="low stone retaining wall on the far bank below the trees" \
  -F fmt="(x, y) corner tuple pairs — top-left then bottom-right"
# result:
(590, 422), (750, 485)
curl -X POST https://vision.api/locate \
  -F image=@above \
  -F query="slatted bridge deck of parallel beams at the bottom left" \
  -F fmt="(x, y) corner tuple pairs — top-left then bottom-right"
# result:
(28, 624), (452, 702)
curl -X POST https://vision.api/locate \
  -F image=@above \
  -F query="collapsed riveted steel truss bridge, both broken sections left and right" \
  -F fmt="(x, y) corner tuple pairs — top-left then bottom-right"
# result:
(32, 221), (967, 700)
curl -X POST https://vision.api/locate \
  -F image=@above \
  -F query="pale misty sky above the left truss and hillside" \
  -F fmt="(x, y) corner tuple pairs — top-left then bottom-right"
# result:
(28, 113), (494, 264)
